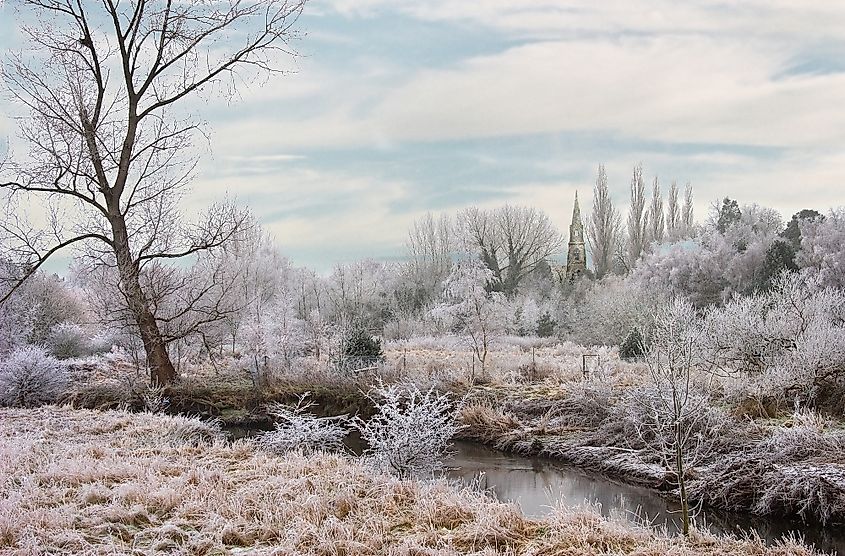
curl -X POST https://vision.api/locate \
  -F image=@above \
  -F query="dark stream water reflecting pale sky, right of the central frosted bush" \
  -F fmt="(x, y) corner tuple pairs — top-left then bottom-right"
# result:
(447, 442), (845, 555)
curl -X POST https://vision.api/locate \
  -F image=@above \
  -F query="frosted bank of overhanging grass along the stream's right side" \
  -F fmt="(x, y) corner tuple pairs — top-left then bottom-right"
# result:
(454, 381), (845, 527)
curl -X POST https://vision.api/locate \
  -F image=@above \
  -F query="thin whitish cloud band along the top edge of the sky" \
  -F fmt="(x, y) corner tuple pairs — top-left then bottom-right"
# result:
(328, 0), (845, 41)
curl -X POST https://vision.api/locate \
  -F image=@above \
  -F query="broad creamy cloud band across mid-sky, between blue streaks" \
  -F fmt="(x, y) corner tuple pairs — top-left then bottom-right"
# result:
(209, 32), (845, 154)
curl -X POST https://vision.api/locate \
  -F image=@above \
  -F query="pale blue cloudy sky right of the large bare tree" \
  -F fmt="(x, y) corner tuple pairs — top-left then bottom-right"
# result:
(0, 0), (845, 271)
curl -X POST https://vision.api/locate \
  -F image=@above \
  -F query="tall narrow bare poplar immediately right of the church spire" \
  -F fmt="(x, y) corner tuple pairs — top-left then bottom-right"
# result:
(587, 165), (622, 278)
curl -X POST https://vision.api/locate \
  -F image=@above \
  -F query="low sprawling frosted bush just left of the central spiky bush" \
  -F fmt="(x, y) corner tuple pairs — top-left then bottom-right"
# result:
(257, 394), (351, 454)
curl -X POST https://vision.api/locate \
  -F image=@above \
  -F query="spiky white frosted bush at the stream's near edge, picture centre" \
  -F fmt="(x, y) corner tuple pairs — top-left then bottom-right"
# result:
(355, 384), (460, 478)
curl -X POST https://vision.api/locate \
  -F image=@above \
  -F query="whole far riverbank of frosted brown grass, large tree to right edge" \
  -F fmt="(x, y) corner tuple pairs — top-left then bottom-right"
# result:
(62, 344), (845, 526)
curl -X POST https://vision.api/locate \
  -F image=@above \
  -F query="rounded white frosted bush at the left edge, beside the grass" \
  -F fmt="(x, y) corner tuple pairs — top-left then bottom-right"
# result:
(0, 346), (67, 407)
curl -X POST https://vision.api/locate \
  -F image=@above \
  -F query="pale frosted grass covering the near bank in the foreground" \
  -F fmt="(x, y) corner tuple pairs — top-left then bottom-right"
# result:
(0, 407), (814, 556)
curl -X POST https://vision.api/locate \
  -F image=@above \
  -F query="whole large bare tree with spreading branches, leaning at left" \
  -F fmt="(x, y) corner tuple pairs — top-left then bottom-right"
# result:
(0, 0), (304, 384)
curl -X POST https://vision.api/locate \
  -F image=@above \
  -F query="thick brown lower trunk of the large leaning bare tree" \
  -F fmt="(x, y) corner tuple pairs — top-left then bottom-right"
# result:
(111, 216), (176, 386)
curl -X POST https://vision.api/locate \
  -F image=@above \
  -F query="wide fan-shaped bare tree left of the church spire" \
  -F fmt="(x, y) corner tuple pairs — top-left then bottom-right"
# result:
(458, 205), (563, 295)
